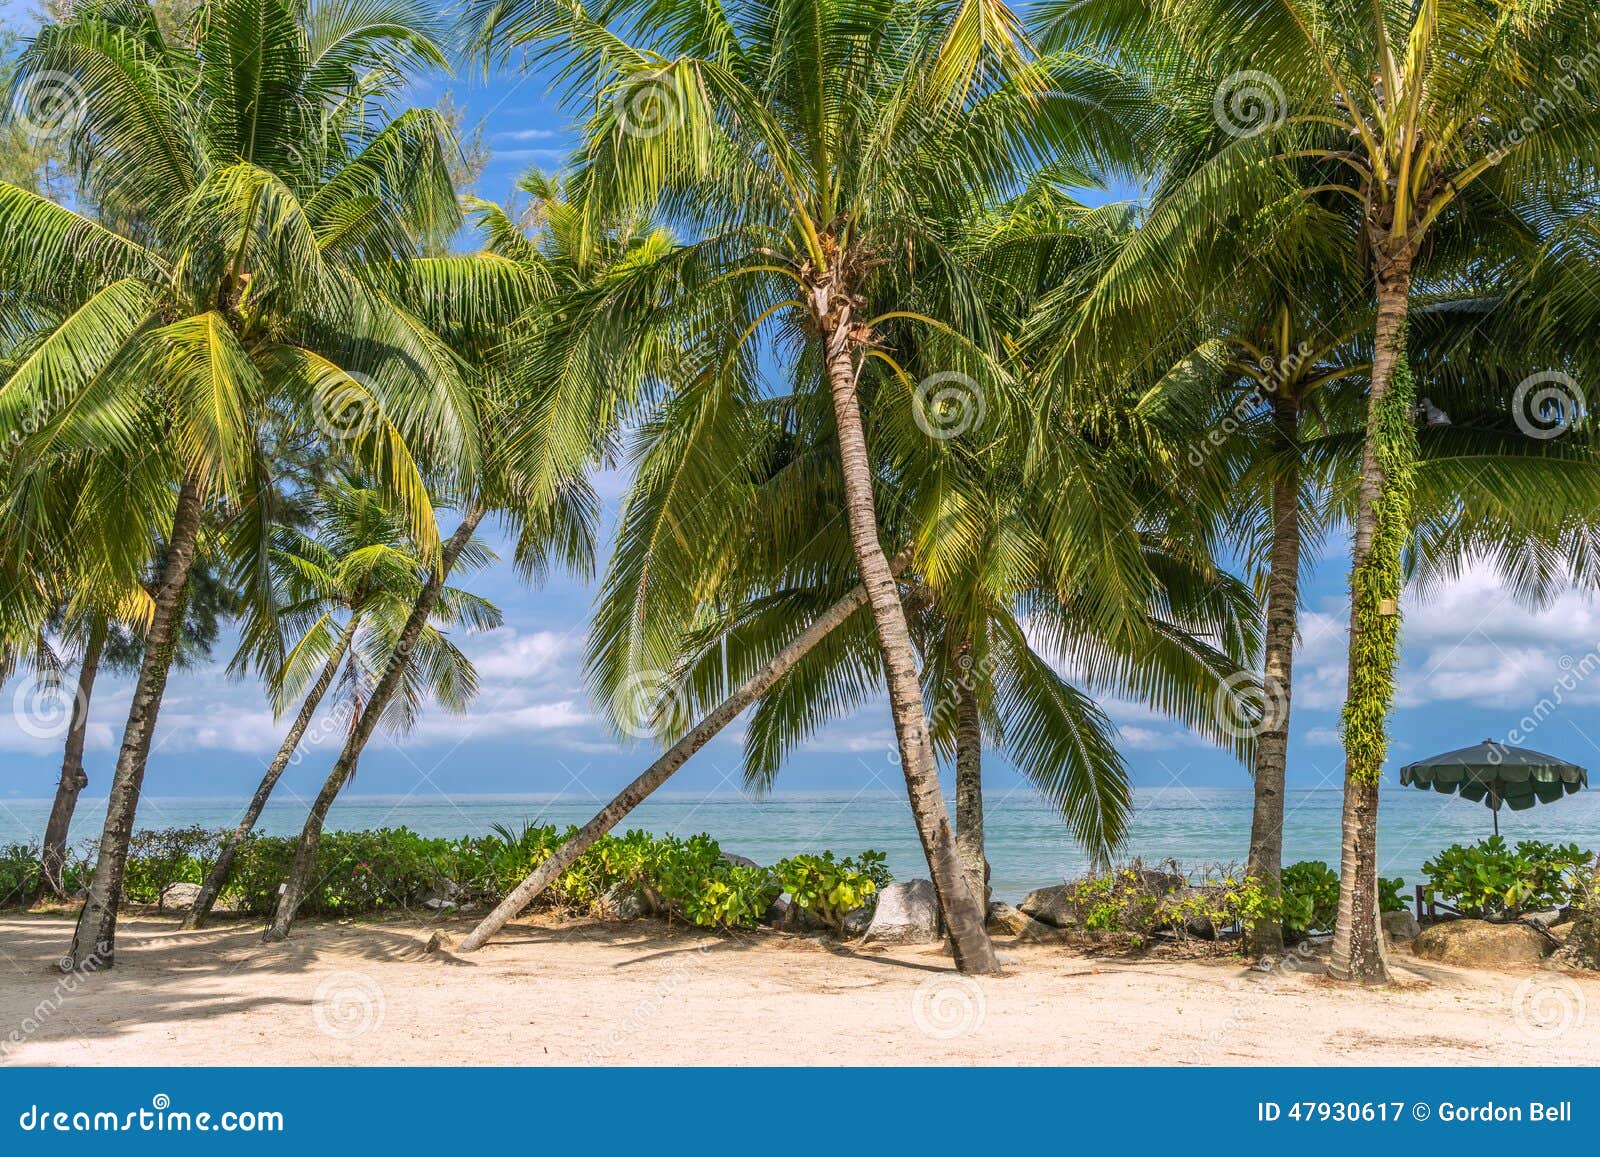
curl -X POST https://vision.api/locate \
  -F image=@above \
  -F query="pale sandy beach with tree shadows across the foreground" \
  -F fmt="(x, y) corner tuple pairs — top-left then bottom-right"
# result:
(0, 915), (1600, 1066)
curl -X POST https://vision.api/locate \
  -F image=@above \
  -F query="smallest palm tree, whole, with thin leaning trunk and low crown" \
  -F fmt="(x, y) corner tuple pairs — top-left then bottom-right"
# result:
(184, 482), (499, 930)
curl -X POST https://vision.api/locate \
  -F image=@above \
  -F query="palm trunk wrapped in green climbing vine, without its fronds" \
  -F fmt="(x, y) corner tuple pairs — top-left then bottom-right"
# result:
(1328, 250), (1414, 984)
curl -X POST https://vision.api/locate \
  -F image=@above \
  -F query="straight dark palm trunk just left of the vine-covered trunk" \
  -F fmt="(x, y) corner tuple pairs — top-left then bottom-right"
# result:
(1250, 397), (1301, 955)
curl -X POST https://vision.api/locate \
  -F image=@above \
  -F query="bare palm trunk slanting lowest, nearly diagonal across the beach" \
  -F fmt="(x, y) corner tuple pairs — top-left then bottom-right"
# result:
(461, 554), (910, 952)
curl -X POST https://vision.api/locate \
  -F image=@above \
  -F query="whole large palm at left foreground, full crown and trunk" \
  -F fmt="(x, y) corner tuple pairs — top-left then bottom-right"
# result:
(0, 0), (474, 968)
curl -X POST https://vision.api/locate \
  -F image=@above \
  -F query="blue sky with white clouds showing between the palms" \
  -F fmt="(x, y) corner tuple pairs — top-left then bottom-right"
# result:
(0, 11), (1600, 799)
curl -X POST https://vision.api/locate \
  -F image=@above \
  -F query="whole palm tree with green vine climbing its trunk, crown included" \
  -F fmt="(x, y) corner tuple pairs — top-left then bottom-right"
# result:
(1040, 0), (1600, 983)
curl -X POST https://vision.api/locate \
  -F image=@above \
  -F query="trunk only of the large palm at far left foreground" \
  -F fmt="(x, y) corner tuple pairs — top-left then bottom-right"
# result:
(61, 475), (200, 971)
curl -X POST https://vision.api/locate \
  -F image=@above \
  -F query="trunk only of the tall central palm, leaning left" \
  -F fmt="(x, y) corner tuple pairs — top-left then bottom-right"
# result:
(813, 278), (1000, 973)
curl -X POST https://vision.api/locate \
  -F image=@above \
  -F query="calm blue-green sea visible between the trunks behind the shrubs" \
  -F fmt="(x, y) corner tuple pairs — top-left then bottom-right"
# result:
(0, 787), (1600, 903)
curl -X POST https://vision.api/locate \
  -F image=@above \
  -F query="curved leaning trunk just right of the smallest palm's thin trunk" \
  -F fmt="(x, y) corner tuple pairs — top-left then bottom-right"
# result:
(262, 506), (486, 941)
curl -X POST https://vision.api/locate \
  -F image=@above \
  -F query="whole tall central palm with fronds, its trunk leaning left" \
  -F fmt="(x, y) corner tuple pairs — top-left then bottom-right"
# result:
(467, 0), (1152, 971)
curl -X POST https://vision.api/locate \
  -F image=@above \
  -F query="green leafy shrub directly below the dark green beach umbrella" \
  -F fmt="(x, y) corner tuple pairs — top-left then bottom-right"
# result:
(1422, 835), (1594, 917)
